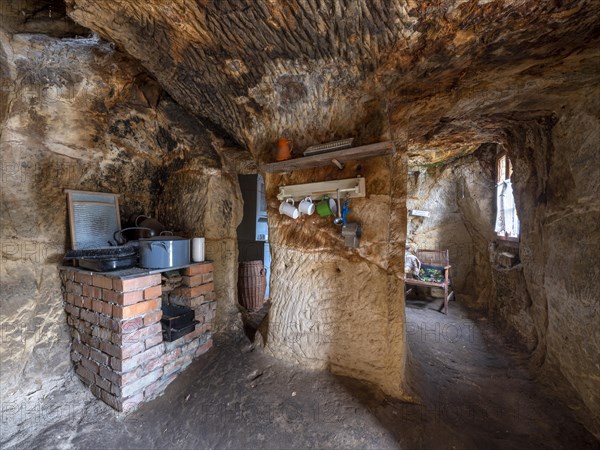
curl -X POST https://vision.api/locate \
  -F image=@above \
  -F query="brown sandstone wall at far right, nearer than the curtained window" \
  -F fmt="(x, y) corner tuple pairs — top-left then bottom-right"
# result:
(505, 103), (600, 435)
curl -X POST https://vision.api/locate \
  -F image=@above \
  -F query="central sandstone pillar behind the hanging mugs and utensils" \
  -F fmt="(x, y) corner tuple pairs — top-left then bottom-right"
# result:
(264, 149), (409, 397)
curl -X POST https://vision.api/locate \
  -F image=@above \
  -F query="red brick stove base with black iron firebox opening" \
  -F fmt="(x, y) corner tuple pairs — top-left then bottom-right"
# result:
(60, 262), (216, 411)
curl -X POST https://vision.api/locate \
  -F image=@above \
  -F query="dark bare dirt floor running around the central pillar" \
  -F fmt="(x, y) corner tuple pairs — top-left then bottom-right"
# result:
(1, 301), (598, 449)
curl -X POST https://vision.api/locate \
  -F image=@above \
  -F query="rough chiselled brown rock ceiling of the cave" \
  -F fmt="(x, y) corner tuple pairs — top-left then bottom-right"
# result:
(66, 0), (600, 162)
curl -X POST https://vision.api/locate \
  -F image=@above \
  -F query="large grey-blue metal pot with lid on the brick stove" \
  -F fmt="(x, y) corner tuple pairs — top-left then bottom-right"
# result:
(139, 236), (190, 269)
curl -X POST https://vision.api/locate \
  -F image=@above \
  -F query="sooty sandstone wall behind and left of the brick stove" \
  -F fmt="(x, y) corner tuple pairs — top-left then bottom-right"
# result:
(0, 32), (240, 442)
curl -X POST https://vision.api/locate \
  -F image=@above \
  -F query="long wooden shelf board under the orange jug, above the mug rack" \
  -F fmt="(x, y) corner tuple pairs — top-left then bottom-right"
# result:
(260, 141), (393, 173)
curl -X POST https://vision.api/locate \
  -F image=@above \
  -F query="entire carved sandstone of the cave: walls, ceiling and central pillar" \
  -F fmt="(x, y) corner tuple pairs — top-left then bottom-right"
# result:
(0, 0), (600, 442)
